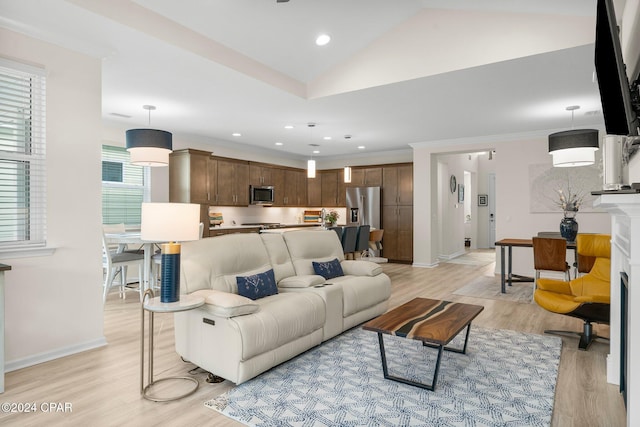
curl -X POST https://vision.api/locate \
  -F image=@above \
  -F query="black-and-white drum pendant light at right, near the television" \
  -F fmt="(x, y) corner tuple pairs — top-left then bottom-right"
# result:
(549, 105), (599, 167)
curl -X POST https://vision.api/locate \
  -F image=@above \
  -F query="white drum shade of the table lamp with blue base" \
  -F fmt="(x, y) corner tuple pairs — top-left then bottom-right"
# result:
(140, 203), (200, 242)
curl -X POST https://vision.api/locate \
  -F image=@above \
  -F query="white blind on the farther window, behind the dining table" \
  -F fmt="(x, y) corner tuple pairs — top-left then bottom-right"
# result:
(102, 145), (150, 226)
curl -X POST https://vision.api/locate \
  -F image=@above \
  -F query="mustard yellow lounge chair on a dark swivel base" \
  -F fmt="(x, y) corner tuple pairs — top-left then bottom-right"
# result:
(534, 234), (611, 350)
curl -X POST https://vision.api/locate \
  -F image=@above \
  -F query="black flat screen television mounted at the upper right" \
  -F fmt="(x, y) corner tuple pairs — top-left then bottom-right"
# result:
(595, 0), (639, 136)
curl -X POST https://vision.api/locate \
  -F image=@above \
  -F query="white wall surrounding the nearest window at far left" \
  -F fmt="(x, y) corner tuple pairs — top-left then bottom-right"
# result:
(0, 29), (105, 370)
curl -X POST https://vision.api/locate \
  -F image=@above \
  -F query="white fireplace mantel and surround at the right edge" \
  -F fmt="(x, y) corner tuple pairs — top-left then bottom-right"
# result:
(594, 193), (640, 426)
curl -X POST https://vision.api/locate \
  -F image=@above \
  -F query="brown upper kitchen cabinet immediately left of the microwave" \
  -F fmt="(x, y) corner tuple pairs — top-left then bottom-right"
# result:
(215, 157), (249, 206)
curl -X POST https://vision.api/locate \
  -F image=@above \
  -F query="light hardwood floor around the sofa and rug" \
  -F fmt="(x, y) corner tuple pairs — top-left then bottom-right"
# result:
(0, 256), (626, 427)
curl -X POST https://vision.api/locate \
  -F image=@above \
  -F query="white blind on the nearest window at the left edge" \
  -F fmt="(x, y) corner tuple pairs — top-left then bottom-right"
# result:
(0, 59), (47, 251)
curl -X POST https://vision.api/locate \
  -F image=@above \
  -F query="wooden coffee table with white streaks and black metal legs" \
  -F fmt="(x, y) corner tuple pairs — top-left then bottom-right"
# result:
(362, 298), (484, 391)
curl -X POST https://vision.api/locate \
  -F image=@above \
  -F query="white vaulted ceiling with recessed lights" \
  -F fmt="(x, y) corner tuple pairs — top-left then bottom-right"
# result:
(0, 0), (603, 158)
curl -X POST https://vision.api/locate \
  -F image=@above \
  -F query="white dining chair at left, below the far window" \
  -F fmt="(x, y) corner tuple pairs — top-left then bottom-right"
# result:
(102, 232), (144, 304)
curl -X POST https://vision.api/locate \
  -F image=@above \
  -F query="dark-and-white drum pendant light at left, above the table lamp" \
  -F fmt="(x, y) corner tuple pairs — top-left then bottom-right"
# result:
(126, 105), (173, 166)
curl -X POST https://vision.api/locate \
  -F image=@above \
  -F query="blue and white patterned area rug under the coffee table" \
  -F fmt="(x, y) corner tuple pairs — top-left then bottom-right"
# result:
(205, 326), (562, 427)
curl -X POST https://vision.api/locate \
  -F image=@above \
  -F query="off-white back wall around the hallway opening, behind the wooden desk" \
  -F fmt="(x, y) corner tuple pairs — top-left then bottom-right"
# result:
(413, 133), (611, 275)
